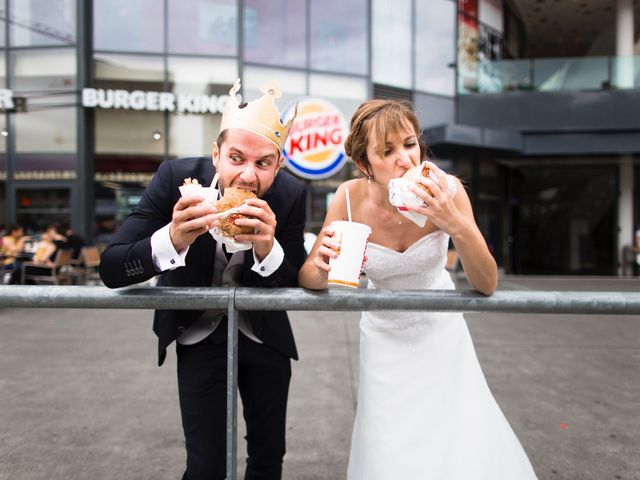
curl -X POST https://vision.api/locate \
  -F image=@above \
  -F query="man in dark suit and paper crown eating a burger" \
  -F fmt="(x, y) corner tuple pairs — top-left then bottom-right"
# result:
(100, 82), (306, 480)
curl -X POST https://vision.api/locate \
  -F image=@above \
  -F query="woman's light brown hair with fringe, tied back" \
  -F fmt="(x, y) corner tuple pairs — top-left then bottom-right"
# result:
(344, 99), (427, 177)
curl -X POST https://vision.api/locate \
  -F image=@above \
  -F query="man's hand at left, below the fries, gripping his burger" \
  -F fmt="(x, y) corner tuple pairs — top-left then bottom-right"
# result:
(169, 195), (216, 252)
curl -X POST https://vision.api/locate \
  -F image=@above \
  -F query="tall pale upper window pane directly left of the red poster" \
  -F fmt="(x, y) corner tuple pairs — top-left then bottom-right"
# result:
(415, 0), (456, 96)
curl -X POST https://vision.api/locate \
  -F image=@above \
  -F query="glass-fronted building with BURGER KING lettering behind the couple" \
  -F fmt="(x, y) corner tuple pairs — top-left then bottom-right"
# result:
(0, 0), (640, 275)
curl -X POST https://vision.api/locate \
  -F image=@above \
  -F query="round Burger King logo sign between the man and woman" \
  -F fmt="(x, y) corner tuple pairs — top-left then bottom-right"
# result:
(283, 98), (349, 180)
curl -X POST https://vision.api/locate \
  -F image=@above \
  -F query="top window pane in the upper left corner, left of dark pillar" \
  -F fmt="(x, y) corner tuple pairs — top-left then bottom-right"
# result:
(8, 0), (76, 47)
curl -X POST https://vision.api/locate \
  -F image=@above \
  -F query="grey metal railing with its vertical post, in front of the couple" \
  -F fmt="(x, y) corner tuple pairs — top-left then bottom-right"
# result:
(0, 286), (640, 480)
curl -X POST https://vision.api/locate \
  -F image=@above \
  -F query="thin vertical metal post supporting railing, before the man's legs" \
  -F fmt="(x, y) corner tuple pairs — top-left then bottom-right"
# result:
(227, 288), (238, 480)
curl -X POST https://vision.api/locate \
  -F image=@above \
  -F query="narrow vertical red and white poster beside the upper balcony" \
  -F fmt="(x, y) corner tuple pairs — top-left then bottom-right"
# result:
(458, 0), (478, 93)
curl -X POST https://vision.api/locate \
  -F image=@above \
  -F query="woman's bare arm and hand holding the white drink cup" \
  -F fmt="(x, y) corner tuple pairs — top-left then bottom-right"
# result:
(298, 183), (347, 290)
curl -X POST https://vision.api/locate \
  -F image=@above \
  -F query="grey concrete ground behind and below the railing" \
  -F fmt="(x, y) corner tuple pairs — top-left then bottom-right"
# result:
(0, 277), (640, 480)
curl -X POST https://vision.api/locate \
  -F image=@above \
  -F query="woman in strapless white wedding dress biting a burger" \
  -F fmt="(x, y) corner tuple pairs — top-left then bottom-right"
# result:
(299, 100), (536, 480)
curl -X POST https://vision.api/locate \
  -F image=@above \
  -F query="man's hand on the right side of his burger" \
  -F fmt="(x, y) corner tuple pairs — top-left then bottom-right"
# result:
(233, 198), (277, 262)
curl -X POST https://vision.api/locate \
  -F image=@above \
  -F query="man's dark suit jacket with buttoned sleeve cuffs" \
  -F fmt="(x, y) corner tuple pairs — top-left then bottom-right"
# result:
(100, 157), (306, 365)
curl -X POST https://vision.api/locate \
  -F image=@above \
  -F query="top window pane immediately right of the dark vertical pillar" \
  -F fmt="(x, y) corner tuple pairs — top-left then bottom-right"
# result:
(93, 0), (164, 52)
